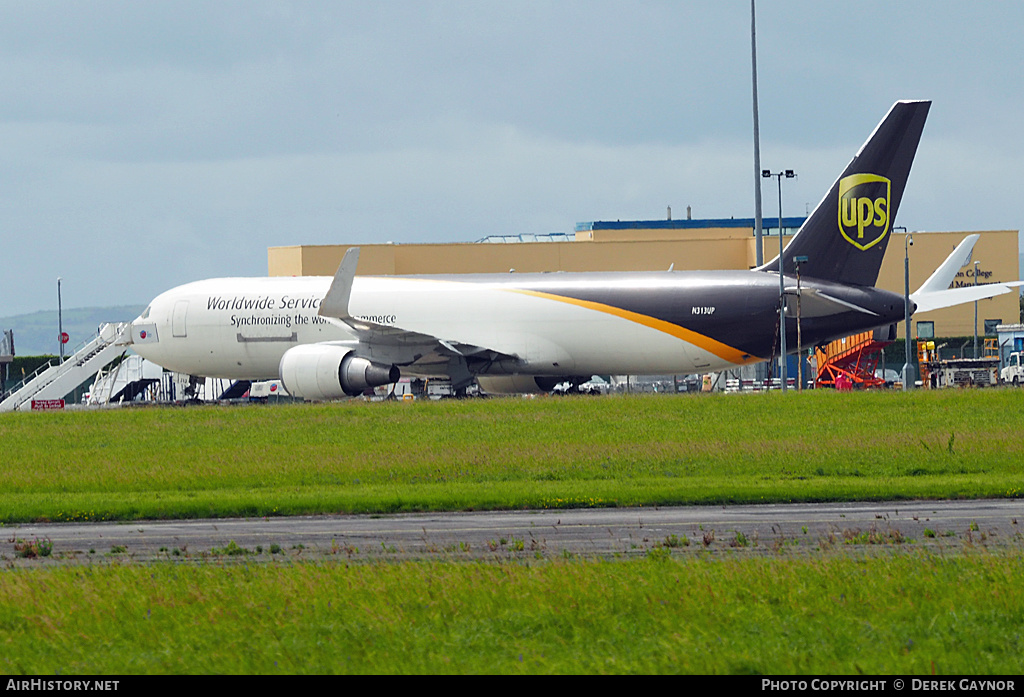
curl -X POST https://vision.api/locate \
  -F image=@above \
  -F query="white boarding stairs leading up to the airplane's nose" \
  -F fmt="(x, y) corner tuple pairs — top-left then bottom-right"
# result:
(0, 322), (131, 411)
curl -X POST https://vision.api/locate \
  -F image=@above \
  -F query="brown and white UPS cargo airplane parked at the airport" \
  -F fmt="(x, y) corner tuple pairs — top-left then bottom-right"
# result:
(131, 101), (1024, 400)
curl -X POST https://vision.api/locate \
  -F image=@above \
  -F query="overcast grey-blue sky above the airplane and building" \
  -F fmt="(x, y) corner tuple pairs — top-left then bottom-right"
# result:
(0, 0), (1024, 316)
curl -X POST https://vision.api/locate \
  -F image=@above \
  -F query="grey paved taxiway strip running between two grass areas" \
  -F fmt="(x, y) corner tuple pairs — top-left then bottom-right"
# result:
(8, 499), (1024, 564)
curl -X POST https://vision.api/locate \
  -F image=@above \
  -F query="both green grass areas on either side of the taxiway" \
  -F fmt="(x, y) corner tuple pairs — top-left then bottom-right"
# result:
(0, 390), (1024, 676)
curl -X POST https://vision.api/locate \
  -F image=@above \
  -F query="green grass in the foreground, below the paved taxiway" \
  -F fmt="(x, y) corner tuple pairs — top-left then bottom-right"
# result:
(0, 553), (1024, 677)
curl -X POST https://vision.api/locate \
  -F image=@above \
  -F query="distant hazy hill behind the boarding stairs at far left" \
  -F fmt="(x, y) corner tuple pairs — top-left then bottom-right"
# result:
(0, 305), (145, 356)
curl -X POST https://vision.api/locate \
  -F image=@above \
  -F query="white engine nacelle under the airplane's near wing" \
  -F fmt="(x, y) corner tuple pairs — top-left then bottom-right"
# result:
(279, 344), (401, 401)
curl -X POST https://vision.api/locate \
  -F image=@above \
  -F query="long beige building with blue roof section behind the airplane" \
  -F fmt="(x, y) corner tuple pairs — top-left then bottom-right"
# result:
(267, 218), (1020, 337)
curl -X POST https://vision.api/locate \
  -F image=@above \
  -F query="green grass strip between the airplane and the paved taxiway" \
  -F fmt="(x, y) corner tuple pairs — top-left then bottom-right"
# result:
(0, 389), (1024, 523)
